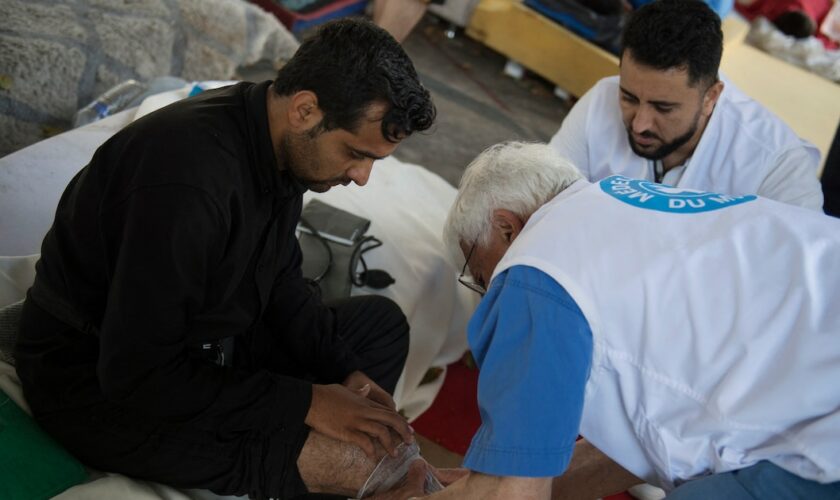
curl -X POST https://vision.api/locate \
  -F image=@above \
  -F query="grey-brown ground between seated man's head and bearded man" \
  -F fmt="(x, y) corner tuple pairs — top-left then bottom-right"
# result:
(395, 15), (568, 185)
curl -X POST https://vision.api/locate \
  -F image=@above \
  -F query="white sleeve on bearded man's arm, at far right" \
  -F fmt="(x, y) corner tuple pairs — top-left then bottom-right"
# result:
(758, 147), (823, 211)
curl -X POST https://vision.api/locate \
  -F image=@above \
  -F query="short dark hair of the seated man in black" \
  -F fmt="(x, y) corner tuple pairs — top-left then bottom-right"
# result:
(274, 18), (436, 142)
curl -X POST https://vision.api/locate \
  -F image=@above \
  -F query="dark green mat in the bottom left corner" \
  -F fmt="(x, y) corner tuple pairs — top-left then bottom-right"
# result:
(0, 390), (87, 500)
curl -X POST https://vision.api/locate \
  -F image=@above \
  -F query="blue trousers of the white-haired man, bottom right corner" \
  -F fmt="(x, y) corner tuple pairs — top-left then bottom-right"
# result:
(666, 461), (840, 500)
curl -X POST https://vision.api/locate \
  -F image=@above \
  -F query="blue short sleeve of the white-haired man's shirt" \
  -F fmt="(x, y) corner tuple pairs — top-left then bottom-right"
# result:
(464, 266), (592, 477)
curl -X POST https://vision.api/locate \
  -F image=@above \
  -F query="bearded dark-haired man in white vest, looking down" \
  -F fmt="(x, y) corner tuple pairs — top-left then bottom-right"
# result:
(551, 0), (823, 210)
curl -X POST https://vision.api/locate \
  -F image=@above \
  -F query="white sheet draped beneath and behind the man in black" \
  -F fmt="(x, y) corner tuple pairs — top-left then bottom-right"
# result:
(0, 87), (478, 499)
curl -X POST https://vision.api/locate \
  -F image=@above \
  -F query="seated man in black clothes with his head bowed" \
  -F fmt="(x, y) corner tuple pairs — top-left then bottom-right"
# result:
(16, 20), (435, 498)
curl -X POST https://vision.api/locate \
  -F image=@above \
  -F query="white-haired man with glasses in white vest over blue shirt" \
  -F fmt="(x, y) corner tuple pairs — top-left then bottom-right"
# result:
(388, 142), (840, 499)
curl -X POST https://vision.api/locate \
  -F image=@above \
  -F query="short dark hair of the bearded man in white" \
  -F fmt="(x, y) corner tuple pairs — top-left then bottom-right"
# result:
(621, 0), (723, 86)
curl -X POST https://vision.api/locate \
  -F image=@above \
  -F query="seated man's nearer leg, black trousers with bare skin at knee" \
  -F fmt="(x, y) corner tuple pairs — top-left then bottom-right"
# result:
(37, 394), (400, 500)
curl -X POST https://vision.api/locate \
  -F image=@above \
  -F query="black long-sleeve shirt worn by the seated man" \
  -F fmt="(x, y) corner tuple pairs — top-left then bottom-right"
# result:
(18, 82), (356, 430)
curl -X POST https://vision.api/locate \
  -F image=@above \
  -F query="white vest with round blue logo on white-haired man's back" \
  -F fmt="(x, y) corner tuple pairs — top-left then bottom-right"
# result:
(494, 176), (840, 489)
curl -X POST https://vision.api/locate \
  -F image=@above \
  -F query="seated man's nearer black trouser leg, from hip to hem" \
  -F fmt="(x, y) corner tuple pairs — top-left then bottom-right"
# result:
(16, 300), (332, 498)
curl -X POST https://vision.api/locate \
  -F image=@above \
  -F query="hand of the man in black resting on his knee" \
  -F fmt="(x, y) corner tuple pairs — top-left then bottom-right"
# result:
(305, 384), (414, 460)
